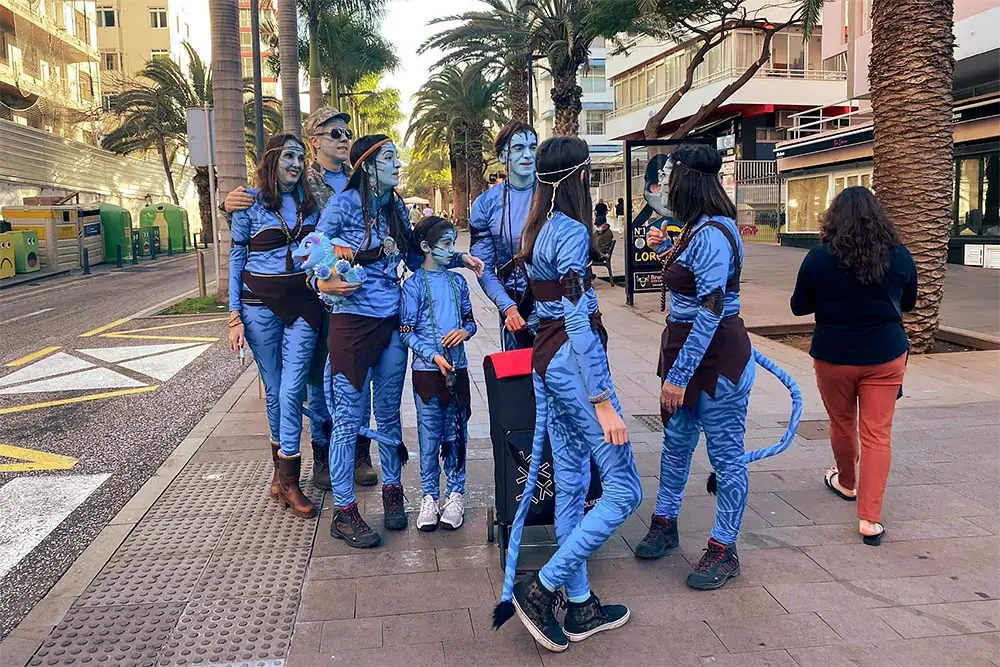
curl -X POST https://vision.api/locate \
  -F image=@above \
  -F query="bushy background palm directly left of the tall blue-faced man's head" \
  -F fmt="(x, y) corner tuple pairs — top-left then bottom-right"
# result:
(406, 66), (504, 223)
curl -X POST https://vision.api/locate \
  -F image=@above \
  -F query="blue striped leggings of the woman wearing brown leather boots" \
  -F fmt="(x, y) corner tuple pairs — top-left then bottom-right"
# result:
(240, 306), (314, 456)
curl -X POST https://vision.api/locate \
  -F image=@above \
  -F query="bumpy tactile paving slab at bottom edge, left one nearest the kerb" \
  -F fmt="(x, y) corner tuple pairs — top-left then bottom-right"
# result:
(28, 603), (184, 667)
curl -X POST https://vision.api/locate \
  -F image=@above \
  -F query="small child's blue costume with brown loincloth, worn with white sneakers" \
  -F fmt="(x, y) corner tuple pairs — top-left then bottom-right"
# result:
(399, 269), (476, 500)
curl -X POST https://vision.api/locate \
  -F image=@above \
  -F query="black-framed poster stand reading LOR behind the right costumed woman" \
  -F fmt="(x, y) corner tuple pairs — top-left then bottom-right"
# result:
(623, 138), (715, 306)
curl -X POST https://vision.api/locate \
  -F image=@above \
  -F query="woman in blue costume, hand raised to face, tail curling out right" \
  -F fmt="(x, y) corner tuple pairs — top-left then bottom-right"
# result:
(635, 146), (798, 590)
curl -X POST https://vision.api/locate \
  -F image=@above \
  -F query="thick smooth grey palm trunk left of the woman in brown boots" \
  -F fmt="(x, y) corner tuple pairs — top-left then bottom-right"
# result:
(209, 0), (247, 303)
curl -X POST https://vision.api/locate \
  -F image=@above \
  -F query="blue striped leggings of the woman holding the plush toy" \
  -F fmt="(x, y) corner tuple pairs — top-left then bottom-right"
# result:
(324, 331), (408, 507)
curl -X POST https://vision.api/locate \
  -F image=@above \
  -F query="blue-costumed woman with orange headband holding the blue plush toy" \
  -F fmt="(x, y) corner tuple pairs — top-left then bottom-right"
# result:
(315, 135), (482, 548)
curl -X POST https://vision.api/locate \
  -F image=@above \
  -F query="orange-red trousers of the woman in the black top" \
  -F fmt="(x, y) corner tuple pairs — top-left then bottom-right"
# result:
(813, 354), (906, 521)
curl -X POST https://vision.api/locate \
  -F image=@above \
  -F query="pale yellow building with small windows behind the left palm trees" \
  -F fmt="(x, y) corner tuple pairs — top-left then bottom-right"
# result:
(96, 0), (197, 98)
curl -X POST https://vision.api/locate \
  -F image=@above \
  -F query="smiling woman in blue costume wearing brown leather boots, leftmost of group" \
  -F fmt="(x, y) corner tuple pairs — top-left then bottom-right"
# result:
(229, 134), (325, 517)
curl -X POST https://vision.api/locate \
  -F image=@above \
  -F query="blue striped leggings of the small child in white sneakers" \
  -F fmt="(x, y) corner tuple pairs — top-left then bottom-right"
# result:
(413, 391), (469, 500)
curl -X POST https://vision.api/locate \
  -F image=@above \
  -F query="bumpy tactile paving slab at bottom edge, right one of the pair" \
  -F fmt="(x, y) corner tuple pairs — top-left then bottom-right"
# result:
(157, 597), (298, 667)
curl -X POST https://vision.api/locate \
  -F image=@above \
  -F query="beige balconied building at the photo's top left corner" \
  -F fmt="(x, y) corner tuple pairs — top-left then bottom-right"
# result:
(0, 0), (101, 144)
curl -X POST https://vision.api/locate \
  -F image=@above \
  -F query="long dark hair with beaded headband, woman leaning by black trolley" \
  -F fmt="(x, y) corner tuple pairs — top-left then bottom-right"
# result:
(521, 137), (594, 262)
